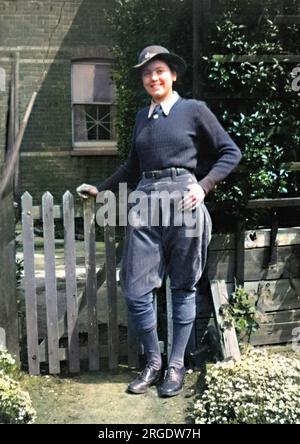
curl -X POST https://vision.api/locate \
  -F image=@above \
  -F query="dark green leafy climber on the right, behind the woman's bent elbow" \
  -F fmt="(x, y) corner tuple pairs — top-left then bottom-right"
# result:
(206, 0), (300, 203)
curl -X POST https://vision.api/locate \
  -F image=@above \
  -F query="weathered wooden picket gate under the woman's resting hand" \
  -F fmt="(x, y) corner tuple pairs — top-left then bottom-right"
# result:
(22, 191), (146, 374)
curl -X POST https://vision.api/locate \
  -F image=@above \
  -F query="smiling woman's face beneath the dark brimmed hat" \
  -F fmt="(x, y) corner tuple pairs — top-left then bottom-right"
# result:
(142, 60), (177, 102)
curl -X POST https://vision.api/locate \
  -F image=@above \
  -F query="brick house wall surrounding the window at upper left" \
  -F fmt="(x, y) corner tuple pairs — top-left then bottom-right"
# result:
(0, 0), (118, 199)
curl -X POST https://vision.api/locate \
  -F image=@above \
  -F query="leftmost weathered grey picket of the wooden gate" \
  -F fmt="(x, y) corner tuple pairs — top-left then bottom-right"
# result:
(22, 192), (40, 375)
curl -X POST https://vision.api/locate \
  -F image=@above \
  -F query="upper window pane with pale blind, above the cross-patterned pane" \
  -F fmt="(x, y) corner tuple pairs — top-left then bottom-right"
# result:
(72, 63), (114, 103)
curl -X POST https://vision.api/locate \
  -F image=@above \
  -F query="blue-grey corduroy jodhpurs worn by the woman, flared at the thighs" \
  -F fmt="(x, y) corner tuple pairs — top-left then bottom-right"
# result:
(121, 172), (211, 332)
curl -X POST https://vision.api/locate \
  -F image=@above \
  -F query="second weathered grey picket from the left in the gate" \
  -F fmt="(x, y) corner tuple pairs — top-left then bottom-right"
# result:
(42, 192), (60, 374)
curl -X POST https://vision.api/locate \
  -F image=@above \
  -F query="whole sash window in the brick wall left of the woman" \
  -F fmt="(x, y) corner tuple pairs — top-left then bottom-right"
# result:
(72, 60), (116, 154)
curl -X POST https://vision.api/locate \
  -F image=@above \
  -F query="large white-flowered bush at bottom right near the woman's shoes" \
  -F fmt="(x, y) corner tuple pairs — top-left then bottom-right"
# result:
(193, 349), (300, 424)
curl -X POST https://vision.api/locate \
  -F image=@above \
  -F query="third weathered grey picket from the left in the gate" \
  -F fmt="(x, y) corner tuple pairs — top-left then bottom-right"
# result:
(63, 191), (80, 373)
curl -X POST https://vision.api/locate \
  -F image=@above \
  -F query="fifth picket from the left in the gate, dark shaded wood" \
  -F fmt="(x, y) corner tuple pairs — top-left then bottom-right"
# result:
(104, 225), (119, 369)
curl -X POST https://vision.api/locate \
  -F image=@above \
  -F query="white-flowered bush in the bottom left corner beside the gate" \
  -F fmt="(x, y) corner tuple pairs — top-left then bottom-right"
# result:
(0, 348), (36, 424)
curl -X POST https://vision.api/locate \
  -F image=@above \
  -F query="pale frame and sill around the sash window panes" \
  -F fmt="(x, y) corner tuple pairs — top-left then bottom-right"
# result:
(71, 58), (118, 156)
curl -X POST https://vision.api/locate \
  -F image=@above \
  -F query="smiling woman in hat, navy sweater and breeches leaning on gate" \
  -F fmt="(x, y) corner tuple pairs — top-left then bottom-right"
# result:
(77, 46), (241, 396)
